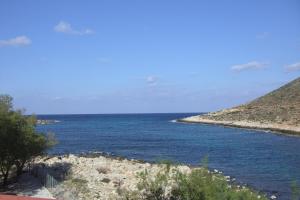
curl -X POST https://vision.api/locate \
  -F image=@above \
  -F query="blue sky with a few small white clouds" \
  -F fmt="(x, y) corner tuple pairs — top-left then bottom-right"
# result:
(0, 0), (300, 114)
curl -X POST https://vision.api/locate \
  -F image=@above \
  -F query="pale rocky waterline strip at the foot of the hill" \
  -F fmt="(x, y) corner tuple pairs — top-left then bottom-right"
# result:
(176, 115), (300, 136)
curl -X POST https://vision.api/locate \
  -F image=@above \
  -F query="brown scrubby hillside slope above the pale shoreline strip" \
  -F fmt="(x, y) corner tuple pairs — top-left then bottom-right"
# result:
(202, 78), (300, 125)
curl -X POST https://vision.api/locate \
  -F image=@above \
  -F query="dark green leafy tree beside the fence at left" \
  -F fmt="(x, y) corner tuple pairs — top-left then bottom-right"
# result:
(0, 95), (55, 185)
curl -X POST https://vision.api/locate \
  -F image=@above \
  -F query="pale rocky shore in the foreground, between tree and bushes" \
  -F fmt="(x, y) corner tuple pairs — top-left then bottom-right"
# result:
(33, 154), (268, 200)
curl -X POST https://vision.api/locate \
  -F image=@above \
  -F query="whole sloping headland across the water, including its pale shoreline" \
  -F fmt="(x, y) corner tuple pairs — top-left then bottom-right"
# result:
(178, 78), (300, 134)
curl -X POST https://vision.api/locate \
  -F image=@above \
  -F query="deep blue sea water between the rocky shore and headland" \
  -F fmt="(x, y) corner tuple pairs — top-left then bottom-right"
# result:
(37, 113), (300, 199)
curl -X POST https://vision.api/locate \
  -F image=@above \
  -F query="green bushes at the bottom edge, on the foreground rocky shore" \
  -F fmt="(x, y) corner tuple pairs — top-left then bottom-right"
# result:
(123, 162), (266, 200)
